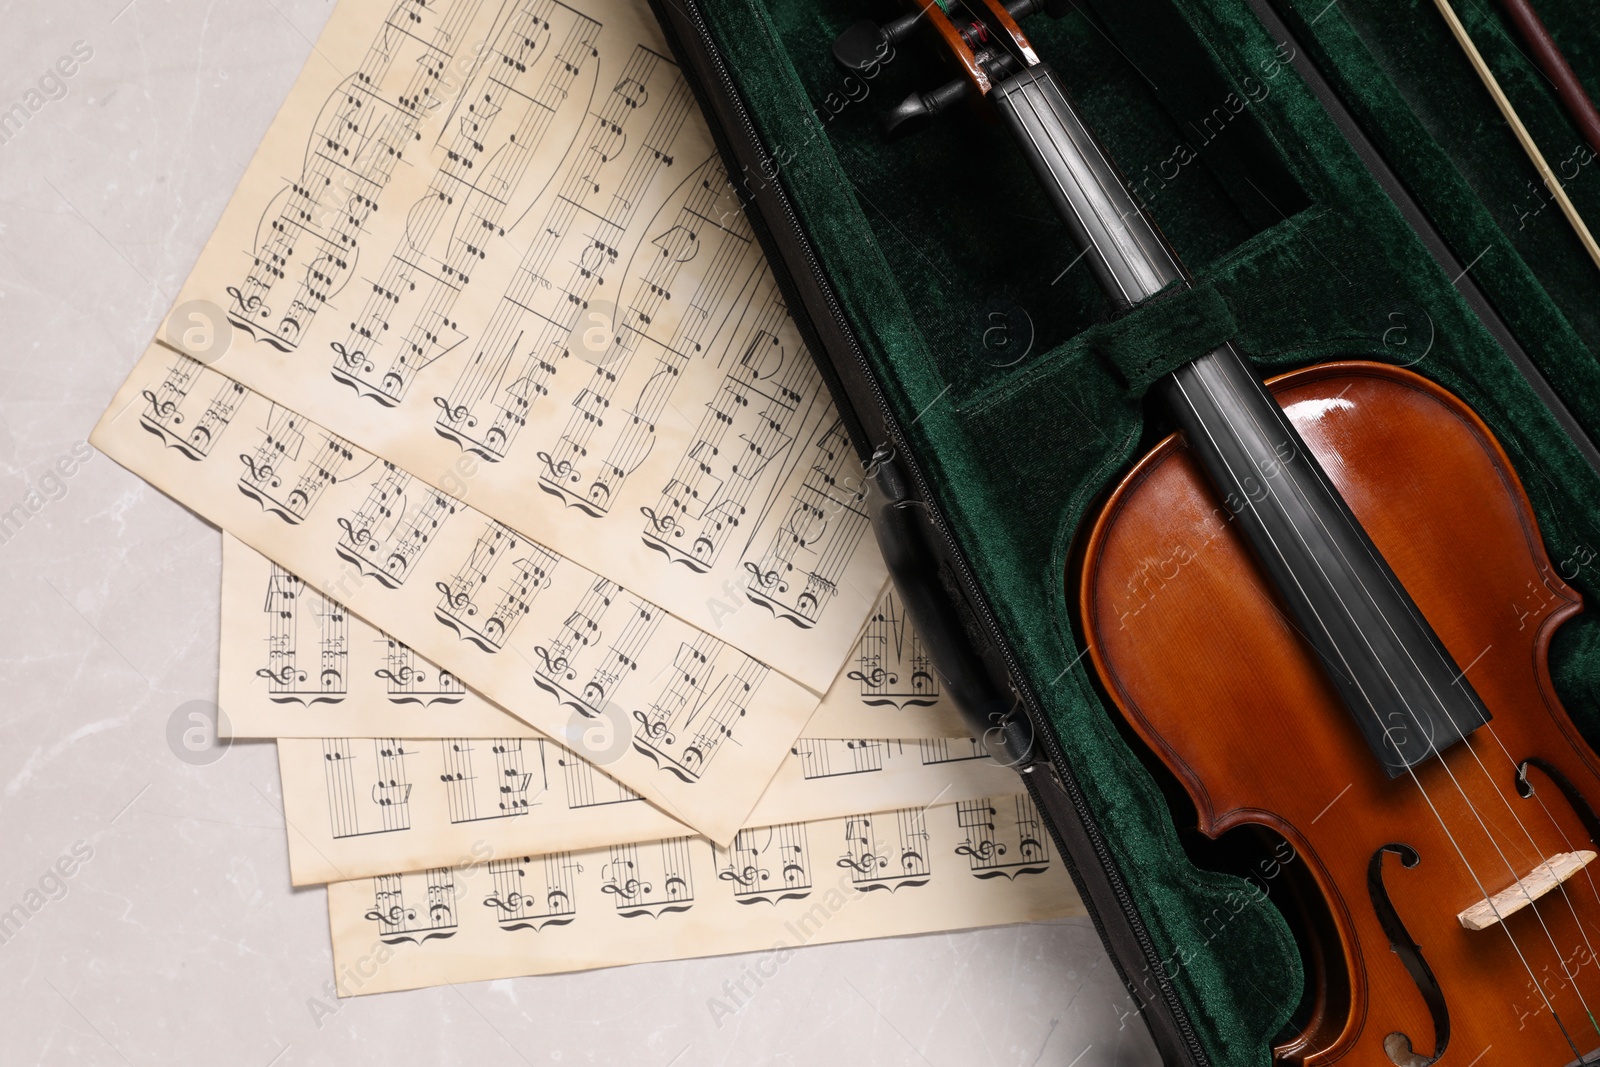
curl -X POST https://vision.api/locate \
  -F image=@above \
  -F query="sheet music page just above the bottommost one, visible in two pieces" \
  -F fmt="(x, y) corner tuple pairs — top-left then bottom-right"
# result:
(278, 737), (1022, 885)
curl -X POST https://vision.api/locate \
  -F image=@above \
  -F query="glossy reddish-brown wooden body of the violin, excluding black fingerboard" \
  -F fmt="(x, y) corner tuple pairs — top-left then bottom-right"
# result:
(1067, 362), (1600, 1067)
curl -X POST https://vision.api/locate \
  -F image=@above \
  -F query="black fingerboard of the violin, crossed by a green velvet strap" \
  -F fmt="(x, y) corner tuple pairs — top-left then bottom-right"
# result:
(990, 64), (1490, 776)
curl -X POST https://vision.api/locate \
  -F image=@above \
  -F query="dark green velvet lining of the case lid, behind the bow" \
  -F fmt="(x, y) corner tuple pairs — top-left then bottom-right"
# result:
(1294, 0), (1600, 441)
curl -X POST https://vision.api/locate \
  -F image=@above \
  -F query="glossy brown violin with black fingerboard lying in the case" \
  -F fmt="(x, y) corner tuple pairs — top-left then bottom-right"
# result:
(834, 0), (1600, 1067)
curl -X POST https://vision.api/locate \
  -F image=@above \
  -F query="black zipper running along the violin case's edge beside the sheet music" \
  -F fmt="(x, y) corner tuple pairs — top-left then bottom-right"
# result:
(650, 0), (1211, 1065)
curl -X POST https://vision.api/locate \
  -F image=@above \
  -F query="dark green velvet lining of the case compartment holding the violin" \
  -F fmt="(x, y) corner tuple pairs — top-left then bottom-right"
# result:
(702, 0), (1600, 1064)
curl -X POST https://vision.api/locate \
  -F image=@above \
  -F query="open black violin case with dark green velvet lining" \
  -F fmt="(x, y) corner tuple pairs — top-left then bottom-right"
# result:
(653, 0), (1600, 1064)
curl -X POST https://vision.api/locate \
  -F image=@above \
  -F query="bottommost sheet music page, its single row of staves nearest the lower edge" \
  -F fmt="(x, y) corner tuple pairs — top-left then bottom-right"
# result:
(318, 795), (1083, 1014)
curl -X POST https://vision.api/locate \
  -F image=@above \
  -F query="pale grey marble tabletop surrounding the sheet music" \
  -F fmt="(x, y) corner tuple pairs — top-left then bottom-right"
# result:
(0, 0), (1155, 1067)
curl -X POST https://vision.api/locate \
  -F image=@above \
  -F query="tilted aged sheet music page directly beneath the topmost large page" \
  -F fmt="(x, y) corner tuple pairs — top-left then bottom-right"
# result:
(90, 346), (818, 841)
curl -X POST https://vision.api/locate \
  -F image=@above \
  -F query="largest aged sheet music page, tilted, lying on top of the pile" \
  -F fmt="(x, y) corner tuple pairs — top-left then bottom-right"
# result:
(137, 0), (885, 693)
